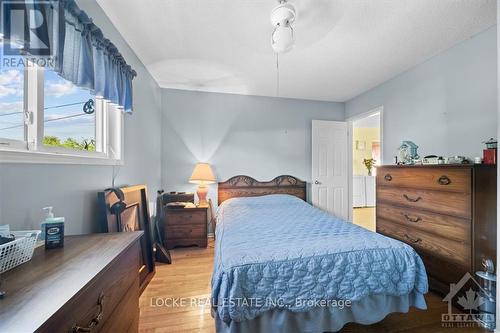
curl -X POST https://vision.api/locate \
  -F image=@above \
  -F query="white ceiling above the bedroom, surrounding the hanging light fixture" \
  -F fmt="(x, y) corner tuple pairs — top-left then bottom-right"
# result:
(97, 0), (496, 102)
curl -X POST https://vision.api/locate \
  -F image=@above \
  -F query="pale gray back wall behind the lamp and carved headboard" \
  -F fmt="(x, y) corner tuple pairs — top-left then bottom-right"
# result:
(162, 89), (345, 199)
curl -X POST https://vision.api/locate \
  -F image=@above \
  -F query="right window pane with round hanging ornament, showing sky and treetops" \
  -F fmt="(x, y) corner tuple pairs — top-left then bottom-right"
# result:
(43, 70), (96, 151)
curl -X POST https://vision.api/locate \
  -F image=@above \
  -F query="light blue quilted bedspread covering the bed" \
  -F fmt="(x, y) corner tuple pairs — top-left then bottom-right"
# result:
(212, 195), (427, 322)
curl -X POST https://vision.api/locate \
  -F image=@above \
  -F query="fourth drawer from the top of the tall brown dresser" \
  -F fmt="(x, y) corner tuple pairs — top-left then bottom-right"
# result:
(377, 219), (471, 267)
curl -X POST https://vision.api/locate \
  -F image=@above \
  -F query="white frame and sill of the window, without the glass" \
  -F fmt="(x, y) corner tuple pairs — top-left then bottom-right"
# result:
(0, 64), (124, 165)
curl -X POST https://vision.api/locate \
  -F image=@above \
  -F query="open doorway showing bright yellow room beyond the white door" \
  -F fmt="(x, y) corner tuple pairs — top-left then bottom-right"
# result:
(350, 108), (382, 231)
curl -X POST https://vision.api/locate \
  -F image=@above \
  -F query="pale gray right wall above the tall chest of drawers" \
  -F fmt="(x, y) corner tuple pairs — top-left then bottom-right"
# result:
(346, 27), (497, 163)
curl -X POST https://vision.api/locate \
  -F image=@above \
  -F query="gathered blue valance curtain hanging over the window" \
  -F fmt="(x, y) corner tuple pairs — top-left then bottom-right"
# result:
(0, 0), (137, 112)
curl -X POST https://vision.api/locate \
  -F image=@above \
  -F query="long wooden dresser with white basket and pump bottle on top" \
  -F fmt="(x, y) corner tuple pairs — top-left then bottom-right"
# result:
(0, 232), (142, 332)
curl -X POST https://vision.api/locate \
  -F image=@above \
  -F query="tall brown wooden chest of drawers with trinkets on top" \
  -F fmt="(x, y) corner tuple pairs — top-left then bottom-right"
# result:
(377, 165), (497, 293)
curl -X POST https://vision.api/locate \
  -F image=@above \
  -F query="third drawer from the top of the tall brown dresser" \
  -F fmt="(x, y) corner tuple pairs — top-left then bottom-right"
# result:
(377, 204), (471, 241)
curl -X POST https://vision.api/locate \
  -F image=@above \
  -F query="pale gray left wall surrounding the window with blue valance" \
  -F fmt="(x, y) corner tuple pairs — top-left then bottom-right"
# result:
(0, 1), (161, 234)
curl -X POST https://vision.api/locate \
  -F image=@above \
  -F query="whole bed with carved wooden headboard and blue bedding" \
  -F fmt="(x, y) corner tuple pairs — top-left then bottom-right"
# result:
(212, 176), (428, 332)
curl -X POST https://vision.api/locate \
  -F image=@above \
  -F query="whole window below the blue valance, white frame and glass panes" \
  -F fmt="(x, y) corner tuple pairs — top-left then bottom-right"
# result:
(0, 62), (123, 164)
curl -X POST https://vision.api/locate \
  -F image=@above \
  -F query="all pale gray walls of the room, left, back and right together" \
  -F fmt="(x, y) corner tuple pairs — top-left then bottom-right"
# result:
(0, 1), (497, 234)
